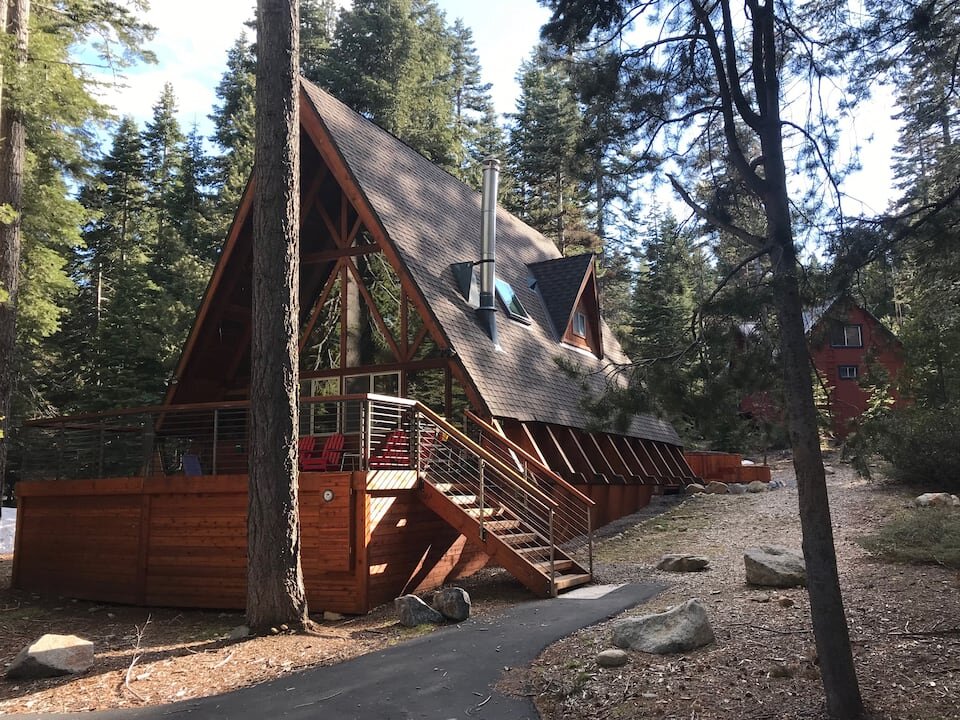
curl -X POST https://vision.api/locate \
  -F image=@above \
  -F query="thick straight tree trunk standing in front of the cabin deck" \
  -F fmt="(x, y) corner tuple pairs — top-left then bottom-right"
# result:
(247, 0), (309, 632)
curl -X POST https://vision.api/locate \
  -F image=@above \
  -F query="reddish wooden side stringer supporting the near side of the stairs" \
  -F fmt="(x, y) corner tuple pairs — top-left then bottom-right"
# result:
(420, 481), (590, 597)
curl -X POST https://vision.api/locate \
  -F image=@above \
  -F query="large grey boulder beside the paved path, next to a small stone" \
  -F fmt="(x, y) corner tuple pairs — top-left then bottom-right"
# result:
(613, 600), (715, 655)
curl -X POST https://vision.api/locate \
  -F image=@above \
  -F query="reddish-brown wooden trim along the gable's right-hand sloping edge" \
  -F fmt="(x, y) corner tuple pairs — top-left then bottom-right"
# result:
(300, 87), (490, 416)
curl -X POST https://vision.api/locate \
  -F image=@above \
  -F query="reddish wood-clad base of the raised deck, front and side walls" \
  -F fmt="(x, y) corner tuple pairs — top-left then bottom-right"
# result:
(13, 471), (488, 613)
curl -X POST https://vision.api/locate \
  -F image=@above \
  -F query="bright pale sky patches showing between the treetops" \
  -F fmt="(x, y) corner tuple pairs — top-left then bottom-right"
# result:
(106, 0), (896, 219)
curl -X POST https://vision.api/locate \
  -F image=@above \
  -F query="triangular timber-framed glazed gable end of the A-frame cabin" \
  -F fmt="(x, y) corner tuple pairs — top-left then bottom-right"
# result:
(165, 83), (484, 412)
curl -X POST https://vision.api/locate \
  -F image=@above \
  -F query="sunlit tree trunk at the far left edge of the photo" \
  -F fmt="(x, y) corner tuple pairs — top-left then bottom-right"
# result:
(0, 0), (30, 500)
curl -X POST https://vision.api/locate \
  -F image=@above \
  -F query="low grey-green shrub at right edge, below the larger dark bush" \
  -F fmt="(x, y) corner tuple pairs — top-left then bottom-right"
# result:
(860, 507), (960, 568)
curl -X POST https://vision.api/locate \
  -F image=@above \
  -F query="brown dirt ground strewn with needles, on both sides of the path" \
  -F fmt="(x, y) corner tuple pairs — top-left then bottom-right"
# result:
(0, 461), (960, 720)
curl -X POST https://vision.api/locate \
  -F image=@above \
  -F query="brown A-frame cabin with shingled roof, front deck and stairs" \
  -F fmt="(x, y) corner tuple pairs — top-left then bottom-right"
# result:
(14, 82), (693, 613)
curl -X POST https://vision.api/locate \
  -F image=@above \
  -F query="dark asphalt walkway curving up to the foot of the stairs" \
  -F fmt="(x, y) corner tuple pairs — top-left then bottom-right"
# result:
(20, 584), (662, 720)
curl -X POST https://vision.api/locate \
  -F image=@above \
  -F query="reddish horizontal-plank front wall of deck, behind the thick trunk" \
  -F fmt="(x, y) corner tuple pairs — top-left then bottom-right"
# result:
(13, 473), (368, 613)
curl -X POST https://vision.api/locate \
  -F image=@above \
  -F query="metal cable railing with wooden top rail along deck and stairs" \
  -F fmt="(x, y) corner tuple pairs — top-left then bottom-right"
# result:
(20, 394), (593, 594)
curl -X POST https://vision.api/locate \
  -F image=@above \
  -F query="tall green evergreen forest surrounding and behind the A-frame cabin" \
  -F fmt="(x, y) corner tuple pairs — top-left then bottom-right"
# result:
(0, 0), (960, 490)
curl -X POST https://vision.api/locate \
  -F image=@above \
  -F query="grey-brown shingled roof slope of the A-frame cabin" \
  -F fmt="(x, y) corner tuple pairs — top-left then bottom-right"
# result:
(303, 81), (680, 445)
